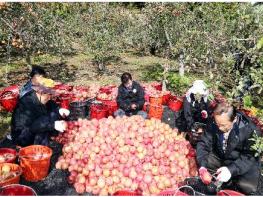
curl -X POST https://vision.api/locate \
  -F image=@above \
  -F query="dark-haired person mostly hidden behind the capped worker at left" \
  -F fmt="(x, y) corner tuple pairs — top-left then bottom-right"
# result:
(19, 66), (46, 98)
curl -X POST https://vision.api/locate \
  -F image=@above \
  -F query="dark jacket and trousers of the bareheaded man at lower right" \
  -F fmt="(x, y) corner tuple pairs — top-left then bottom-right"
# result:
(197, 112), (261, 194)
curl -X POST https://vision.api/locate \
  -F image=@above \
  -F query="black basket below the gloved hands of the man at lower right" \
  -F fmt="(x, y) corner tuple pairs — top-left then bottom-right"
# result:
(184, 177), (217, 195)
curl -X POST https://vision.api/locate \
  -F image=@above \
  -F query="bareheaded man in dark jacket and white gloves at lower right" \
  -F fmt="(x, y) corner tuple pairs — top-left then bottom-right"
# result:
(196, 103), (262, 195)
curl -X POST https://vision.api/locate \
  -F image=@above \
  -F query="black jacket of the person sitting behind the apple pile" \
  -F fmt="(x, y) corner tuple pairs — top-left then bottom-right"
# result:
(117, 81), (145, 116)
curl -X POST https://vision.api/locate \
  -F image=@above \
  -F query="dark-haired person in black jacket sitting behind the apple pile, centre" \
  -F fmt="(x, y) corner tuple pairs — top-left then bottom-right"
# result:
(114, 73), (147, 118)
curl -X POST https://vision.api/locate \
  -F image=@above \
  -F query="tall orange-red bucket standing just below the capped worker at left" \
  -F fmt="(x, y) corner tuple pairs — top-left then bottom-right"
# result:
(19, 145), (53, 181)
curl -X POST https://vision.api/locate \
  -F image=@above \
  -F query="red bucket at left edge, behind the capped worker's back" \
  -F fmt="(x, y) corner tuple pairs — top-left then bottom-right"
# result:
(0, 91), (18, 112)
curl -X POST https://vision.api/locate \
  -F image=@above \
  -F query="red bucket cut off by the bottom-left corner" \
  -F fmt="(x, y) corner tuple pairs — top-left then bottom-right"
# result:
(0, 184), (37, 196)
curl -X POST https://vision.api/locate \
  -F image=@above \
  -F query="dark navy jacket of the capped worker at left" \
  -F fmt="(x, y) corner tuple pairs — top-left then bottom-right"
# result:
(11, 90), (61, 146)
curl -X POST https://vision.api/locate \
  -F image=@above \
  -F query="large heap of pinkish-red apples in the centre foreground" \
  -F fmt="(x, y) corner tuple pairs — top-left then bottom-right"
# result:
(56, 116), (197, 195)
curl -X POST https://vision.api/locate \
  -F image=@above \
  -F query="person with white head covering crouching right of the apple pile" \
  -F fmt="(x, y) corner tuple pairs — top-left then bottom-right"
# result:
(177, 80), (210, 146)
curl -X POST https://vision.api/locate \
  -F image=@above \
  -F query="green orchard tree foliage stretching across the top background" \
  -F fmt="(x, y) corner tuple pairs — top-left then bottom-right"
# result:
(0, 3), (263, 106)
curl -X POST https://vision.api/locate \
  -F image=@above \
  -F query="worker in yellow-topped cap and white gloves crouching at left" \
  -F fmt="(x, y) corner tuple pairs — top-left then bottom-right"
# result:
(11, 78), (69, 146)
